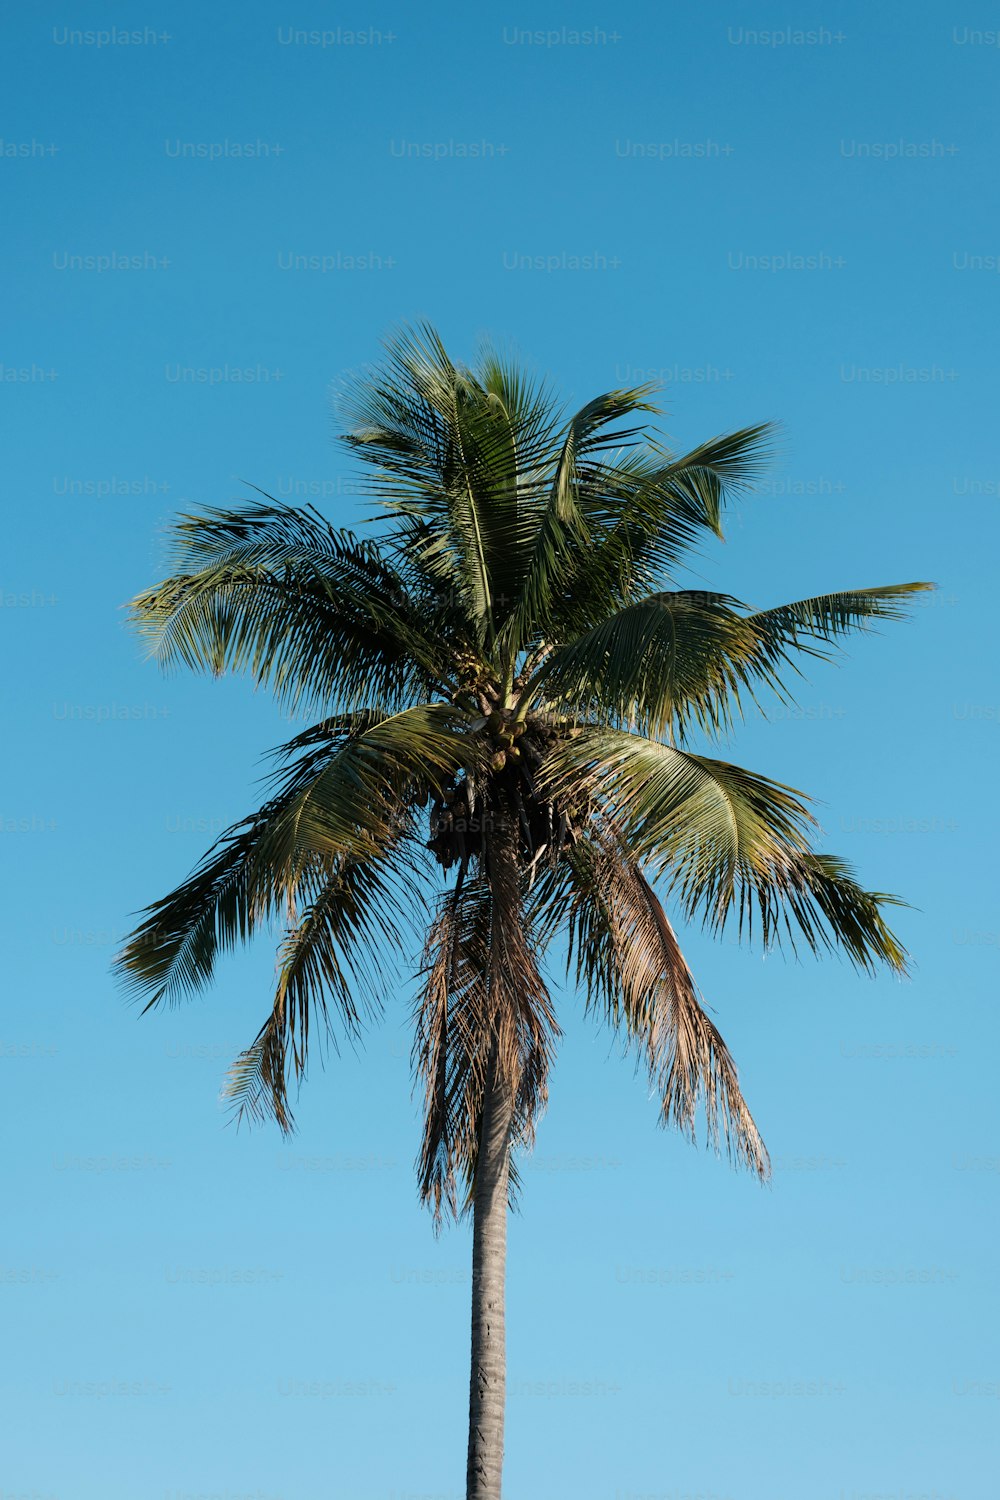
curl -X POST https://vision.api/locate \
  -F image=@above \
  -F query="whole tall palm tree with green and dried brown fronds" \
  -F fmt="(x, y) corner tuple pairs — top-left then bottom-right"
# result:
(117, 327), (930, 1500)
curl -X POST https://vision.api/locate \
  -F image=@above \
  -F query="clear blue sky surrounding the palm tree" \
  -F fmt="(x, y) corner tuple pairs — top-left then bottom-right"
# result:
(0, 0), (1000, 1500)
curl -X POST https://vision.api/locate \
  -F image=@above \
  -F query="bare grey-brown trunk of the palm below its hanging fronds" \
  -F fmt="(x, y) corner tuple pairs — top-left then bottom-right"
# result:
(465, 1062), (511, 1500)
